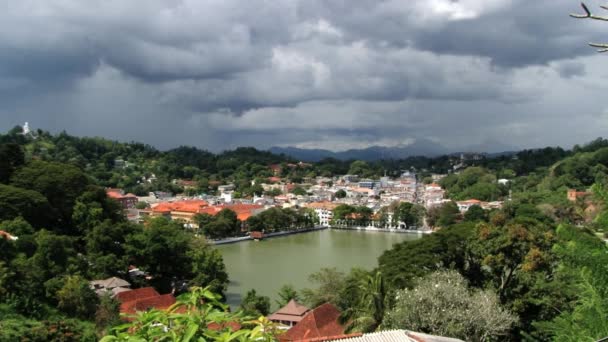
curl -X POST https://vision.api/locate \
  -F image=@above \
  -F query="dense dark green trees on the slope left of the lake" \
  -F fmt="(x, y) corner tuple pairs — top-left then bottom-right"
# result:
(0, 138), (228, 341)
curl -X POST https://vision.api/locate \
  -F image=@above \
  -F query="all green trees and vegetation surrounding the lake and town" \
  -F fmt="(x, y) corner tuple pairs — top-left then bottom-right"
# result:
(0, 130), (608, 341)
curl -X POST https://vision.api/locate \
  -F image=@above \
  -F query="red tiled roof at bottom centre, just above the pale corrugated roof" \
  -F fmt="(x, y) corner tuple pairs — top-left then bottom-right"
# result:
(279, 303), (344, 342)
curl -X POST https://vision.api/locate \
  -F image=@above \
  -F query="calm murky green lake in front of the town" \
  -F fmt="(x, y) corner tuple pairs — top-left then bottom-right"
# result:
(215, 229), (421, 310)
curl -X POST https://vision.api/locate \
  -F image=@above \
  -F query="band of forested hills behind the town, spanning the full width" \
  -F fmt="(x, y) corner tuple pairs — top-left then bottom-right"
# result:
(0, 127), (608, 196)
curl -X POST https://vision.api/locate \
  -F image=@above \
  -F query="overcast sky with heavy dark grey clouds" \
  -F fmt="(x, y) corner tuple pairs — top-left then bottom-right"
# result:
(0, 0), (608, 151)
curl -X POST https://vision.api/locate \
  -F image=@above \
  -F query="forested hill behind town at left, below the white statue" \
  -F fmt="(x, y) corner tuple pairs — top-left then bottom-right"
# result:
(0, 127), (296, 195)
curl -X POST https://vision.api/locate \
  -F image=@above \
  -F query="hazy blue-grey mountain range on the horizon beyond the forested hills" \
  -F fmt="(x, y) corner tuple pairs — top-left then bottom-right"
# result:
(269, 139), (518, 162)
